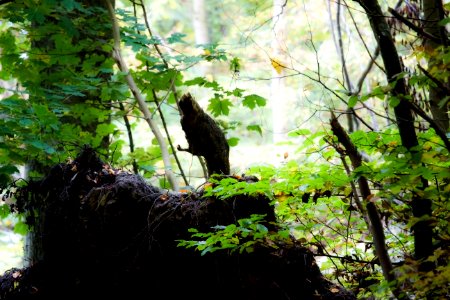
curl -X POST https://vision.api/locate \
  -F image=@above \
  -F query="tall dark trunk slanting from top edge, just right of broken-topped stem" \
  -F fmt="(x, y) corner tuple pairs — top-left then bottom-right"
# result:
(358, 0), (433, 259)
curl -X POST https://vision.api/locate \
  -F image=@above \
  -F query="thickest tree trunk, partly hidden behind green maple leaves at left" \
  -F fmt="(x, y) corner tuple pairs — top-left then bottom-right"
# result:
(24, 0), (112, 264)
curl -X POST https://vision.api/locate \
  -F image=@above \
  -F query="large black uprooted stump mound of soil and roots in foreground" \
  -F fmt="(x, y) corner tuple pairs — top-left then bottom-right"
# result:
(0, 148), (355, 300)
